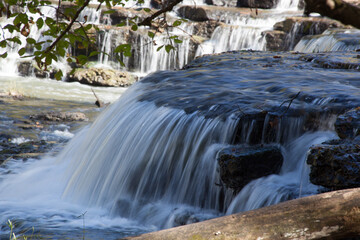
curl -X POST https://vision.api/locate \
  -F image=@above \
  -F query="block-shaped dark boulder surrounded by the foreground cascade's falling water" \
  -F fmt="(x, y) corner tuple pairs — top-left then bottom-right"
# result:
(218, 146), (283, 192)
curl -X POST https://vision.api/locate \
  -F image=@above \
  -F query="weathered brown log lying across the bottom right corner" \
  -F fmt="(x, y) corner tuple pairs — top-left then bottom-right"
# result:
(126, 188), (360, 240)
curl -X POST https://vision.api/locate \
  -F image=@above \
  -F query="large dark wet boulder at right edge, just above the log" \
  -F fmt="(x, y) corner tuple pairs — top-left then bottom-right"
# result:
(307, 139), (360, 190)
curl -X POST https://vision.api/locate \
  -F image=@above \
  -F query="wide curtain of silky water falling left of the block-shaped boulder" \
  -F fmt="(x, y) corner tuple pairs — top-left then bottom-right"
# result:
(58, 84), (236, 226)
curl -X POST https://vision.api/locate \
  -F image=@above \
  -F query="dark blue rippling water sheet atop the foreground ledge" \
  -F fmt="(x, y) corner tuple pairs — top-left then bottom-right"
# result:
(139, 51), (360, 119)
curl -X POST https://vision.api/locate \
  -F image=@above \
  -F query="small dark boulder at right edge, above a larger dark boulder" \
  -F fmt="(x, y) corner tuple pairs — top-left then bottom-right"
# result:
(335, 107), (360, 139)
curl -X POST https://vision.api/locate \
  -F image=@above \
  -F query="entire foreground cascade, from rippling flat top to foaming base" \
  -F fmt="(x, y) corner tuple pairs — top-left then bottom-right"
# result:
(0, 51), (360, 239)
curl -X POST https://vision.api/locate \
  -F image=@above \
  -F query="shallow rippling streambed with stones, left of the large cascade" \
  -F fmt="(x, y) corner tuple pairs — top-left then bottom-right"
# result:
(0, 94), (100, 163)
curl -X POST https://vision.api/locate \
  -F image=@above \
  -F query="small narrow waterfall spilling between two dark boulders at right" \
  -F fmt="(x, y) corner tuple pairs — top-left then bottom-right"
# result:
(226, 132), (336, 214)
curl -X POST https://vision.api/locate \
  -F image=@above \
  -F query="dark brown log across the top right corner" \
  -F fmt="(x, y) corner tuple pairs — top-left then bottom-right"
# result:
(305, 0), (360, 28)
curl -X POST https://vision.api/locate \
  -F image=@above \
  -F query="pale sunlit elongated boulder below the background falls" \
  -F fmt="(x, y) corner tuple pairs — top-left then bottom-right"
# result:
(68, 68), (137, 87)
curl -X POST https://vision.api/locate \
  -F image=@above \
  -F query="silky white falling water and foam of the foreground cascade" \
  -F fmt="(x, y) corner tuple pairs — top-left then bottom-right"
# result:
(0, 67), (344, 239)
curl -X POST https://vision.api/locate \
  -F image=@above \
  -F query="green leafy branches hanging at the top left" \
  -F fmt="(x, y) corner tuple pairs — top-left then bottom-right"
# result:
(0, 0), (185, 79)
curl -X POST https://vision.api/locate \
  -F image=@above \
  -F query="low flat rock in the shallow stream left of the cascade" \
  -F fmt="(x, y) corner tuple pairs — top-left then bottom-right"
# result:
(30, 112), (88, 122)
